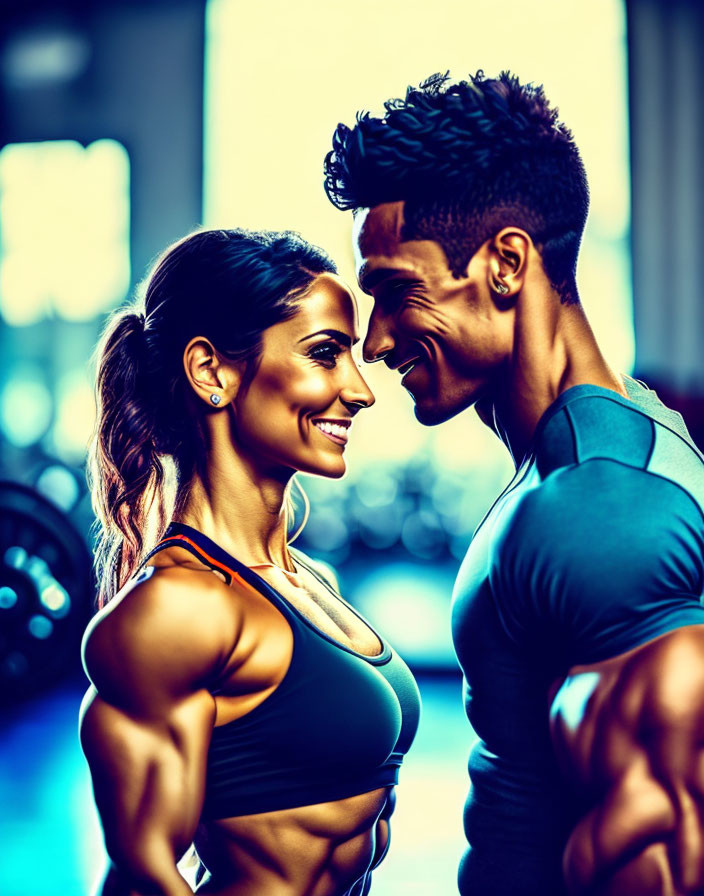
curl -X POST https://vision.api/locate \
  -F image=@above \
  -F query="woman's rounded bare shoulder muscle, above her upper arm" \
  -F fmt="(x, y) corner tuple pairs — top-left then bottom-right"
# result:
(82, 564), (244, 699)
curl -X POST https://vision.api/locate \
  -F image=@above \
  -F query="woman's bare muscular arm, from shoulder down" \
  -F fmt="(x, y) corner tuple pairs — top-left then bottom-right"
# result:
(81, 569), (238, 896)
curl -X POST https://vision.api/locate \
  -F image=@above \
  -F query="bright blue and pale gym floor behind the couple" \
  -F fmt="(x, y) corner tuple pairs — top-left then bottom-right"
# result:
(0, 678), (472, 896)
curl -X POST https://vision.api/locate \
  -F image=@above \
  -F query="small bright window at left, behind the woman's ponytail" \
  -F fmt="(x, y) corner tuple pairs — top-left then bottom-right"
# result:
(0, 140), (130, 326)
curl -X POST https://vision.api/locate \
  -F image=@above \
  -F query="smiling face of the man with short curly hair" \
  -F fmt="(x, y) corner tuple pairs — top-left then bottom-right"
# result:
(355, 202), (512, 426)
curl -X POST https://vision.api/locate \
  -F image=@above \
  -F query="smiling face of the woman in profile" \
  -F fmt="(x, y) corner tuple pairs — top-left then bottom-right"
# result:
(233, 274), (374, 478)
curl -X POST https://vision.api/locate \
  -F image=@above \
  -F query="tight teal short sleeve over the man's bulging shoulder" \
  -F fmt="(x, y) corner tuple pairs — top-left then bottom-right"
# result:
(490, 459), (704, 667)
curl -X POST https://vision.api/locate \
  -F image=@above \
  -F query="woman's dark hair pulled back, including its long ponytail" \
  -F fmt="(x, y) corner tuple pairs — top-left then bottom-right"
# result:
(89, 230), (336, 606)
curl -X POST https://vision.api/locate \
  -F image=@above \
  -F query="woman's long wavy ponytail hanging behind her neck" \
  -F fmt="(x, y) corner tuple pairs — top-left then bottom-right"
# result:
(89, 310), (165, 606)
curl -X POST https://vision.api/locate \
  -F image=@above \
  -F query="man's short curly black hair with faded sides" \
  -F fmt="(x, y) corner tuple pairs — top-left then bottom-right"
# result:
(325, 71), (589, 303)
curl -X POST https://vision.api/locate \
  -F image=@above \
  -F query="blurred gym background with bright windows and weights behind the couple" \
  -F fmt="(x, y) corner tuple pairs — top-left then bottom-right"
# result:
(0, 0), (704, 896)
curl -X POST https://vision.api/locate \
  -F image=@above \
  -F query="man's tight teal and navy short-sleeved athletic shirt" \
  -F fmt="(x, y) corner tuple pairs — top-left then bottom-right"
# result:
(452, 379), (704, 896)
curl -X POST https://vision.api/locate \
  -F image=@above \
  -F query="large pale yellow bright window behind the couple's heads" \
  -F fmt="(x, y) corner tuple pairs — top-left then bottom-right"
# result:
(204, 0), (633, 472)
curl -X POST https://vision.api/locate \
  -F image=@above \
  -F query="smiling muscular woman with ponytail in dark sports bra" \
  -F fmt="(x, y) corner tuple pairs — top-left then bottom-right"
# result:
(81, 230), (420, 896)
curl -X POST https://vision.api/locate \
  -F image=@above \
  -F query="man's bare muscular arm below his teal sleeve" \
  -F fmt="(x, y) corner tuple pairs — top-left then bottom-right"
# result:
(551, 625), (704, 896)
